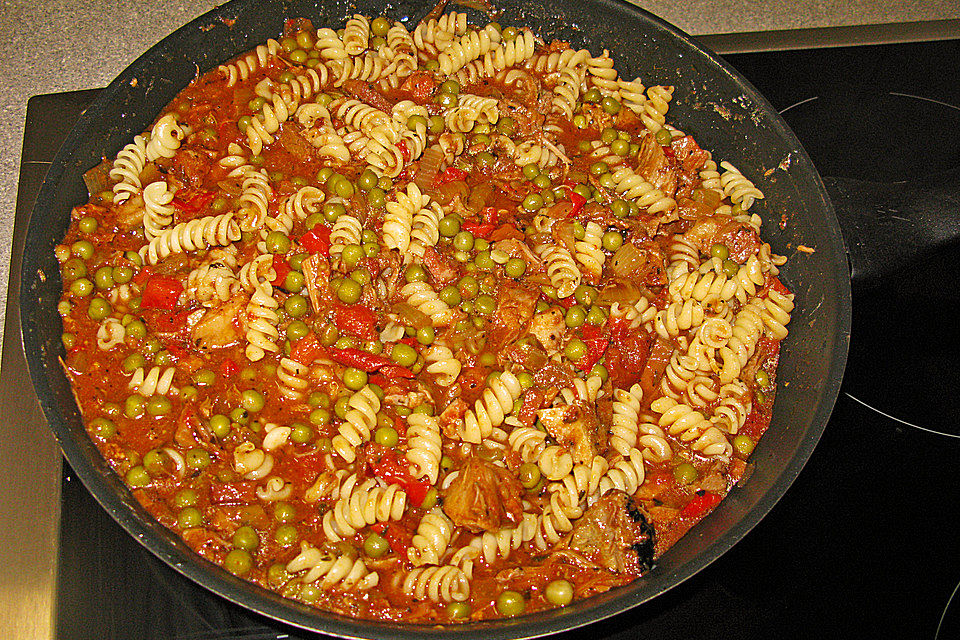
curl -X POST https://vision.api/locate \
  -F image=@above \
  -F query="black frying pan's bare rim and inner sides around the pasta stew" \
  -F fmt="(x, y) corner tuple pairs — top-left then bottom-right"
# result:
(20, 0), (851, 639)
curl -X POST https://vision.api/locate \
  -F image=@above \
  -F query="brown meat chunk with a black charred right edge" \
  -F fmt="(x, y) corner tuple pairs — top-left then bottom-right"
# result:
(557, 489), (656, 575)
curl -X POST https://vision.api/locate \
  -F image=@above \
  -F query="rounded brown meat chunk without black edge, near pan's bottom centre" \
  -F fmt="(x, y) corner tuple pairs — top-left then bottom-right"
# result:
(443, 458), (523, 533)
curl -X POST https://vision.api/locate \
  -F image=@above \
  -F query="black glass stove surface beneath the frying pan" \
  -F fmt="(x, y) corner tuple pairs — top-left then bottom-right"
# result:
(21, 36), (960, 639)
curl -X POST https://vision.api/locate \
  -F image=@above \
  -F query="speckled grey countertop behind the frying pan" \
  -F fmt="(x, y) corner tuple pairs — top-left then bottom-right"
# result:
(0, 0), (960, 348)
